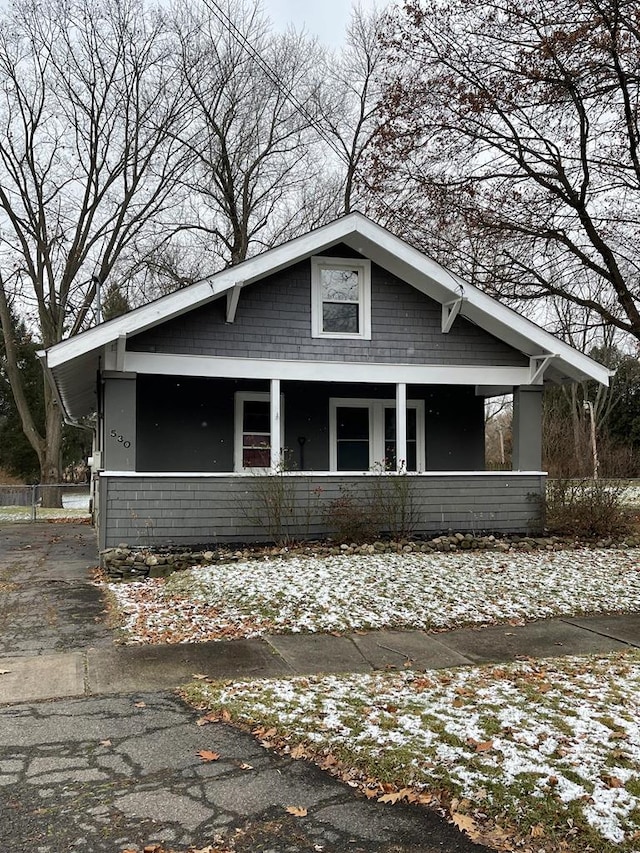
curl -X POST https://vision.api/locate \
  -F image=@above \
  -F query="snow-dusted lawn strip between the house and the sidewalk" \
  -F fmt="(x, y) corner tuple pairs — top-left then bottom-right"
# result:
(109, 548), (640, 643)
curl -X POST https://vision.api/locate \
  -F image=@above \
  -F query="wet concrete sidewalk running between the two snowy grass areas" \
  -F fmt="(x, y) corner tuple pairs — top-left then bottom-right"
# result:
(0, 614), (640, 704)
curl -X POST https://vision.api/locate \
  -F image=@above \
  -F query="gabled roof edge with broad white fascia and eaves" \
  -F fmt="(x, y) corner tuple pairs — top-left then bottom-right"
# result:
(41, 213), (610, 418)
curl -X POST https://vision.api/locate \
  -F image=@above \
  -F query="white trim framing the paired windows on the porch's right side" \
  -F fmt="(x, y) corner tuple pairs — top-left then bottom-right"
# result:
(329, 397), (426, 474)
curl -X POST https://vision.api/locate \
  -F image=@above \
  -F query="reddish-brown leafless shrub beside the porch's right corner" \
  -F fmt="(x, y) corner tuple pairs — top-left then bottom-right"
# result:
(545, 479), (631, 537)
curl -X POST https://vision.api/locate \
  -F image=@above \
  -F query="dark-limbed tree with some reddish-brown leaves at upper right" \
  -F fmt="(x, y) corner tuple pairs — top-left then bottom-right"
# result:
(375, 0), (640, 338)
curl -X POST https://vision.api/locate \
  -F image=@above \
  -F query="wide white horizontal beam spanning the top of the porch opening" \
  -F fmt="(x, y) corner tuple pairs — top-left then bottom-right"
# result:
(125, 352), (530, 386)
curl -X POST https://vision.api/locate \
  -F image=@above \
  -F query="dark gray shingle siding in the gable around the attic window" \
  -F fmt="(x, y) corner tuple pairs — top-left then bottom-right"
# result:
(127, 260), (528, 366)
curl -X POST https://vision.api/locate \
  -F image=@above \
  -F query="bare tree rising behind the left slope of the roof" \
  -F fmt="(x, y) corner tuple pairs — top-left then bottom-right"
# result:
(161, 0), (319, 274)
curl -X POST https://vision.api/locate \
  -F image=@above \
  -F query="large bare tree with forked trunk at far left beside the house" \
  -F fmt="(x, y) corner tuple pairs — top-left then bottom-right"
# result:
(0, 0), (192, 483)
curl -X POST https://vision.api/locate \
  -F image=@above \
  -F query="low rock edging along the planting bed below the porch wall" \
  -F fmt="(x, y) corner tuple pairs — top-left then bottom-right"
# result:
(100, 533), (640, 581)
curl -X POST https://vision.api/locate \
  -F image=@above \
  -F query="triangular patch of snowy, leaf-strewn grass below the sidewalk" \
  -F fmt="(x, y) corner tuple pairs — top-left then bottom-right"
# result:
(186, 652), (640, 851)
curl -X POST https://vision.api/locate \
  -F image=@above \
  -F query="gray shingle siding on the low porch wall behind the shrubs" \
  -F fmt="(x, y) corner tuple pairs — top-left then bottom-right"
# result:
(100, 472), (545, 548)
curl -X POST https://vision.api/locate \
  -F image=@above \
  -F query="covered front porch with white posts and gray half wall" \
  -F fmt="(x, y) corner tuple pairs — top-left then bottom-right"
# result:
(96, 353), (545, 548)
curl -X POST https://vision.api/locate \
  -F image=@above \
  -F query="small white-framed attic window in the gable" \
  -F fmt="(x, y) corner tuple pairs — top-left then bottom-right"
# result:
(311, 257), (371, 340)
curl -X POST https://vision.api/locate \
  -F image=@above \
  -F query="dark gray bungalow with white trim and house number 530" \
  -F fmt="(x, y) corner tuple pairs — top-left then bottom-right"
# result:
(42, 213), (609, 548)
